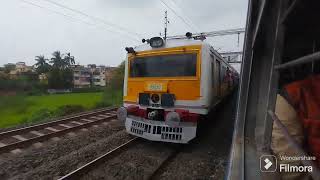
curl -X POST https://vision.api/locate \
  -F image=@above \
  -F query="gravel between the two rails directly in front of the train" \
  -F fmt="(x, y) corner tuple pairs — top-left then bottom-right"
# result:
(82, 139), (177, 180)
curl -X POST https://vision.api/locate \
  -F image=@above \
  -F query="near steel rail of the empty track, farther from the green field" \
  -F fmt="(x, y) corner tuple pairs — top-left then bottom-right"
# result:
(0, 115), (116, 154)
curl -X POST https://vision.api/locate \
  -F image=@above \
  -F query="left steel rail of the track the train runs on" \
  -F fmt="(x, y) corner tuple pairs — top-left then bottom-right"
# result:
(58, 137), (138, 180)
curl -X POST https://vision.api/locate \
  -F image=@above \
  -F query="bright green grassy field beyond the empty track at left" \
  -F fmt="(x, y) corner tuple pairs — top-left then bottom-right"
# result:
(0, 92), (105, 128)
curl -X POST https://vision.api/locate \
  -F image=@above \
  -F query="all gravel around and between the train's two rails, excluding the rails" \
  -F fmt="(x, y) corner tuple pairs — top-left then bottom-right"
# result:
(0, 94), (236, 180)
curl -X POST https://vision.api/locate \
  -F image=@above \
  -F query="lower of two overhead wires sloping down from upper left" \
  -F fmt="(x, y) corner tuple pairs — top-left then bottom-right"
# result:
(20, 0), (139, 41)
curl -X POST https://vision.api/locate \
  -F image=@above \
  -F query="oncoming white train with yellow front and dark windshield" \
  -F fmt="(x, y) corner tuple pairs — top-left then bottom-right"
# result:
(117, 33), (239, 144)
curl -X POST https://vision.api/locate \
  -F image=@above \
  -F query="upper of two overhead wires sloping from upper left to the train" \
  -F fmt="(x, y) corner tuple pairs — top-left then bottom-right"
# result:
(43, 0), (142, 39)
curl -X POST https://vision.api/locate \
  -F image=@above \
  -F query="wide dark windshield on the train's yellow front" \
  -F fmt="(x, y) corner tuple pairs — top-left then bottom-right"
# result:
(130, 54), (197, 77)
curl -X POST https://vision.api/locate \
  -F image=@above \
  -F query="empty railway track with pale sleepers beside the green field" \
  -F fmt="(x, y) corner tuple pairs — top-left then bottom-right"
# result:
(0, 108), (117, 154)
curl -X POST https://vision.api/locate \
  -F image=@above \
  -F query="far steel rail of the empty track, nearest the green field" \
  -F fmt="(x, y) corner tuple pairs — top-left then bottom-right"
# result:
(0, 107), (117, 139)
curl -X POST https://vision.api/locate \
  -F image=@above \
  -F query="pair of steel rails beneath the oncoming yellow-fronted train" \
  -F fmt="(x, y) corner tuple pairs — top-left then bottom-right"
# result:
(59, 137), (181, 180)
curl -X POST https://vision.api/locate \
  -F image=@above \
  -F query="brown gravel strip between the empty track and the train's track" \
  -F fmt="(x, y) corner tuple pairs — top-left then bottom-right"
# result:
(0, 121), (129, 179)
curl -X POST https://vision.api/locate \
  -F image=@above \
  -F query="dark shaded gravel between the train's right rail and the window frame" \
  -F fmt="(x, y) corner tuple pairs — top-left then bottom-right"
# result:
(154, 93), (236, 180)
